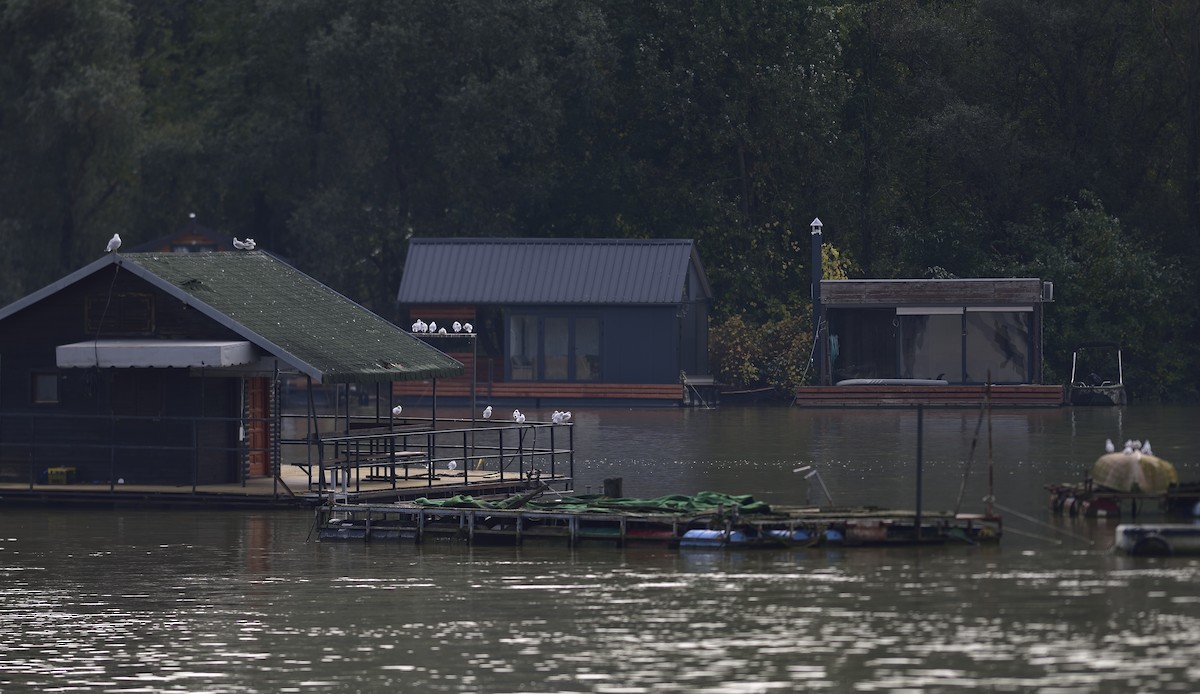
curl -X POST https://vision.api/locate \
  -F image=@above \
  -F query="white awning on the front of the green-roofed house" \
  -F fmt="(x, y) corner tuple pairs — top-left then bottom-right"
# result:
(55, 340), (257, 369)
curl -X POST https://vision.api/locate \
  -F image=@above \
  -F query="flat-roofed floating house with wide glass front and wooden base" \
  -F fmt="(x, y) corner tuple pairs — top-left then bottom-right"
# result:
(796, 279), (1062, 406)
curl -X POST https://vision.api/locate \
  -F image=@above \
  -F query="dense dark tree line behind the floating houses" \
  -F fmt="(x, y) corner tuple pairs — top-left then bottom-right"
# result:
(0, 0), (1200, 397)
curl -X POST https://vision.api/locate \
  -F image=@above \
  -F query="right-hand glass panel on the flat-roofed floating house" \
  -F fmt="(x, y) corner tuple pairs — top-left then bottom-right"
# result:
(966, 309), (1032, 383)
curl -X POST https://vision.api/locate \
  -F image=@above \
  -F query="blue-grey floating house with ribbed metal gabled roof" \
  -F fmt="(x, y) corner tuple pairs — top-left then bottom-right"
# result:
(395, 239), (712, 405)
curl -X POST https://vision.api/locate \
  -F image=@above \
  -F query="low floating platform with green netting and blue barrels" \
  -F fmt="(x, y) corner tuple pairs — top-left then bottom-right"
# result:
(313, 492), (1002, 549)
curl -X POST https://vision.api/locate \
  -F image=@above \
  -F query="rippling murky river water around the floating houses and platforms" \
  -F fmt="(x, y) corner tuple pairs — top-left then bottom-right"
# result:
(0, 406), (1200, 693)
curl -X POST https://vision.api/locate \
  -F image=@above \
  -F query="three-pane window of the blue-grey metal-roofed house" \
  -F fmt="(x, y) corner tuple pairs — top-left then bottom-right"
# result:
(509, 315), (601, 381)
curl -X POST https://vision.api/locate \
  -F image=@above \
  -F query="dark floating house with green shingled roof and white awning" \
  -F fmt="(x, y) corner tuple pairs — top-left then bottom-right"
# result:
(0, 251), (463, 499)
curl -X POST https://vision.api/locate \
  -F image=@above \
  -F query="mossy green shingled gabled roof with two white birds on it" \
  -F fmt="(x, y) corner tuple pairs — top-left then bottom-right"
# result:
(0, 251), (463, 383)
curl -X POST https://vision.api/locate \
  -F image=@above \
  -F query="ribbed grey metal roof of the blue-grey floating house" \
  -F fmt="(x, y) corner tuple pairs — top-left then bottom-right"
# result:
(397, 239), (712, 304)
